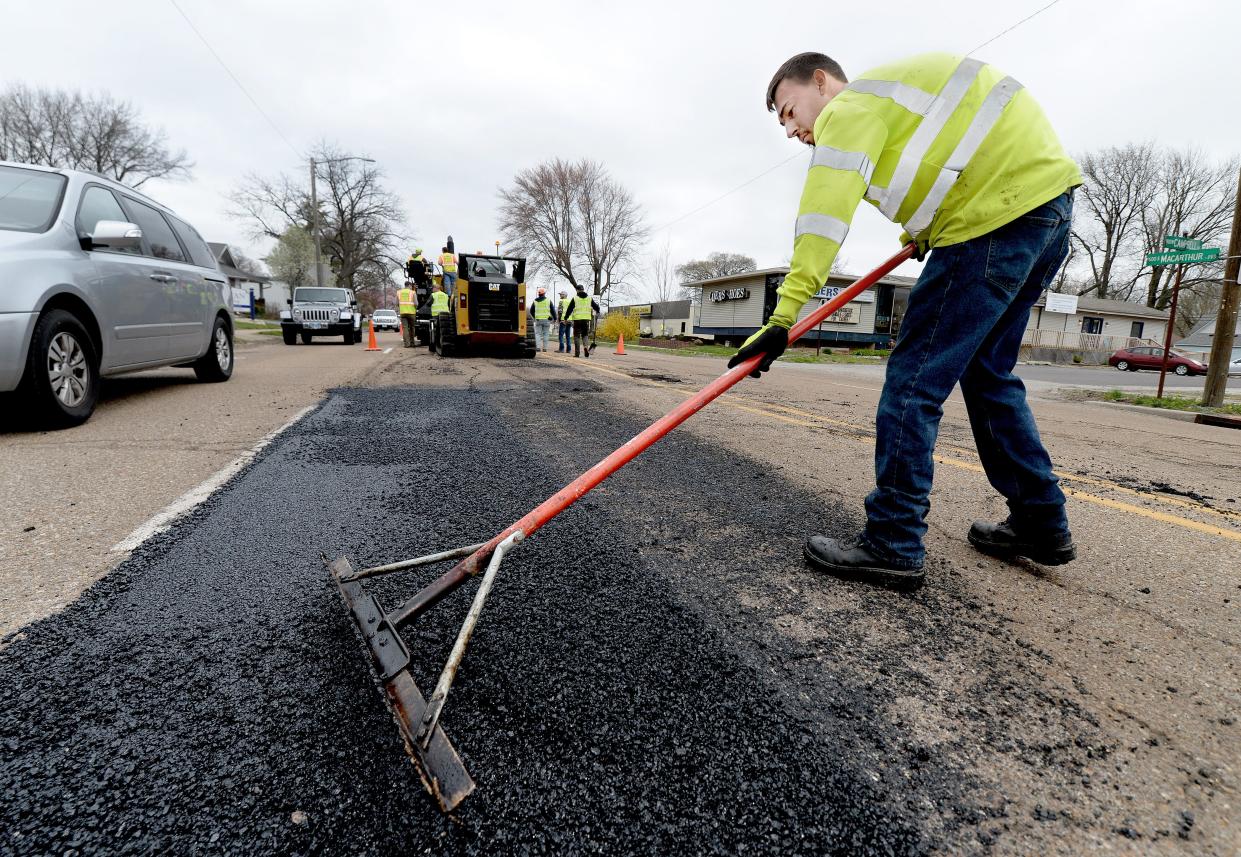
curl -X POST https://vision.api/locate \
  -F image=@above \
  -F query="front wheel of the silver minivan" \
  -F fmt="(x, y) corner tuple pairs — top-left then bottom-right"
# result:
(21, 310), (99, 428)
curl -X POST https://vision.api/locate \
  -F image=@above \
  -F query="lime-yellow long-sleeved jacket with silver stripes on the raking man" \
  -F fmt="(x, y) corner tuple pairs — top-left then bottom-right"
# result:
(771, 53), (1082, 326)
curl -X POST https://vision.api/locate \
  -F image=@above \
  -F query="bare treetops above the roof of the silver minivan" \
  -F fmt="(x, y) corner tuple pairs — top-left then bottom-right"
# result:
(0, 83), (192, 187)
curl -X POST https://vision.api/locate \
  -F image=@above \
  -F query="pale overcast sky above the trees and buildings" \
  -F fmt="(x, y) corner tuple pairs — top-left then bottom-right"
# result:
(0, 0), (1241, 296)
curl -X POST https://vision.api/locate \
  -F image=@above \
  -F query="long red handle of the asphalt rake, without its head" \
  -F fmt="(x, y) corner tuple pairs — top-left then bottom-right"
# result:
(441, 244), (915, 587)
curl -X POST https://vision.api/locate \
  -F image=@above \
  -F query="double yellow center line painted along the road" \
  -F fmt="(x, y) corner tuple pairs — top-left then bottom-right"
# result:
(555, 357), (1241, 542)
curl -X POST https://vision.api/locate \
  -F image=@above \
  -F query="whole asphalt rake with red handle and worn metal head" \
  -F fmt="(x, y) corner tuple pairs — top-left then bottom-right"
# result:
(325, 244), (916, 812)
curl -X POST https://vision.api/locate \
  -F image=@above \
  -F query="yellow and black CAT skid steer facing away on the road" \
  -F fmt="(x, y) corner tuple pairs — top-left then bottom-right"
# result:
(431, 253), (535, 357)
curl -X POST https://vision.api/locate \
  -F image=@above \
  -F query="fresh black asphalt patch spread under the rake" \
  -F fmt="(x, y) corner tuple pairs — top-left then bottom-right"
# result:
(0, 382), (1116, 855)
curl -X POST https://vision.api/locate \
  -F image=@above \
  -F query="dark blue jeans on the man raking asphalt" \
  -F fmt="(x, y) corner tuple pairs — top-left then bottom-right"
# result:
(860, 191), (1073, 568)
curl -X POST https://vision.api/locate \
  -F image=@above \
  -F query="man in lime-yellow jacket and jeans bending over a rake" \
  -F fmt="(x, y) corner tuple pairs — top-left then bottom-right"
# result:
(728, 53), (1081, 585)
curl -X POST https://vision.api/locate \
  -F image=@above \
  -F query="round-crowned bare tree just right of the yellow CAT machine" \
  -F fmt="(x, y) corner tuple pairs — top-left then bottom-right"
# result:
(499, 159), (648, 296)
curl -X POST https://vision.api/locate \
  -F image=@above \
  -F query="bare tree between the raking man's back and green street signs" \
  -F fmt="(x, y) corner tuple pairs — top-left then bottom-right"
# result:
(1072, 143), (1159, 300)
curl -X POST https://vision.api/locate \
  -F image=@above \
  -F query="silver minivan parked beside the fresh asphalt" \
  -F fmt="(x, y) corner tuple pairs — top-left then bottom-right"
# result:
(0, 161), (233, 427)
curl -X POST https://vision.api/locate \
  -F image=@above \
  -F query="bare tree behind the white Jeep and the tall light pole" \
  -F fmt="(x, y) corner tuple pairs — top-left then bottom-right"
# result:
(230, 144), (410, 306)
